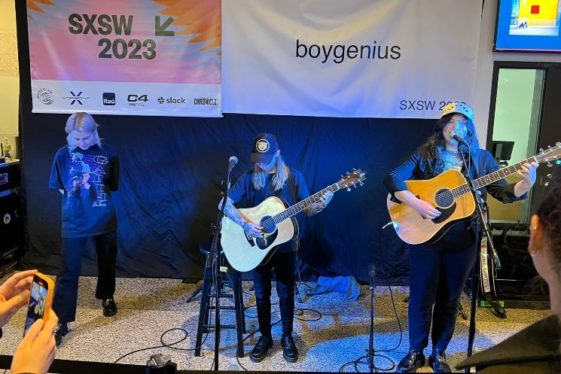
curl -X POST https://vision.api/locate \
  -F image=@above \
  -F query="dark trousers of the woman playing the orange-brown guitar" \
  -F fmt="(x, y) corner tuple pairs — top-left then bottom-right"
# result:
(408, 222), (477, 352)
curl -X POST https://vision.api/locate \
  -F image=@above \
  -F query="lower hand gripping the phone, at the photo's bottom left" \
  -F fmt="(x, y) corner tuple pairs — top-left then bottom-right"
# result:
(10, 309), (58, 374)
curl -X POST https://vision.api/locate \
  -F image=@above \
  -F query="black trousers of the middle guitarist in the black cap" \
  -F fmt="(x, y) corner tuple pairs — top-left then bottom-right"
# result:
(253, 251), (296, 337)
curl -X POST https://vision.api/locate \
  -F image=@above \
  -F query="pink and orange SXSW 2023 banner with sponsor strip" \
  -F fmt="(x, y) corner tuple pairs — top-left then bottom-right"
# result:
(27, 0), (222, 117)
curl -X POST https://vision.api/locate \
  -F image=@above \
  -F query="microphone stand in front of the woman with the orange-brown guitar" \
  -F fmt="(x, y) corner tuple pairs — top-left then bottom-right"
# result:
(458, 144), (498, 366)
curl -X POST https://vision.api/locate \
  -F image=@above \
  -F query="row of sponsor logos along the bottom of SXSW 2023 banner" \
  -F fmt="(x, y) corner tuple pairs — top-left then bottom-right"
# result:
(37, 88), (217, 107)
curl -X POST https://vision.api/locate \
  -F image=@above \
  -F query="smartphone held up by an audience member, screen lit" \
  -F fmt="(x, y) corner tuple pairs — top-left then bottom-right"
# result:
(23, 273), (55, 336)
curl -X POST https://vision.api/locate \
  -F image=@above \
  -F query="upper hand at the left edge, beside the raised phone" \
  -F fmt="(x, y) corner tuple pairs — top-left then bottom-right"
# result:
(0, 270), (37, 327)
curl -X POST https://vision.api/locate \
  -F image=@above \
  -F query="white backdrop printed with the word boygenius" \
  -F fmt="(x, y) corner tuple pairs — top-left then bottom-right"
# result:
(222, 0), (482, 118)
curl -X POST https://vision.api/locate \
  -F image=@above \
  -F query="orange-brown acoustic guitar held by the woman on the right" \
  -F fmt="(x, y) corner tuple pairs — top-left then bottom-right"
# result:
(387, 142), (561, 244)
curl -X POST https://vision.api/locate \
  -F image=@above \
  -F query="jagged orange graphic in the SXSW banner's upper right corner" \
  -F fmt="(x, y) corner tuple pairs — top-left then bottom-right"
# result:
(153, 0), (222, 51)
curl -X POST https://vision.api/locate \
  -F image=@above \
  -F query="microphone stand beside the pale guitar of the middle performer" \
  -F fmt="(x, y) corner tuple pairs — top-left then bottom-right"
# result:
(209, 162), (235, 371)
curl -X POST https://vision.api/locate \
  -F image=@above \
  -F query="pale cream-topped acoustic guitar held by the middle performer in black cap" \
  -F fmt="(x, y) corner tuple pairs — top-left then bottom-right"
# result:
(220, 169), (366, 271)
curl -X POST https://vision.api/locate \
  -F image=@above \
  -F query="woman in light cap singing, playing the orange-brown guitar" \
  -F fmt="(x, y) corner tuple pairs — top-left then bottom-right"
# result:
(384, 102), (538, 372)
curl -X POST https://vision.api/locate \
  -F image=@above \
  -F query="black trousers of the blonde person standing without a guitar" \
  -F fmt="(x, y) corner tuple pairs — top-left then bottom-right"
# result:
(53, 231), (117, 322)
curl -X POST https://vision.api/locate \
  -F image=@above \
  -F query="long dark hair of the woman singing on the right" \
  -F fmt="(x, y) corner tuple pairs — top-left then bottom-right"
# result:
(419, 113), (479, 175)
